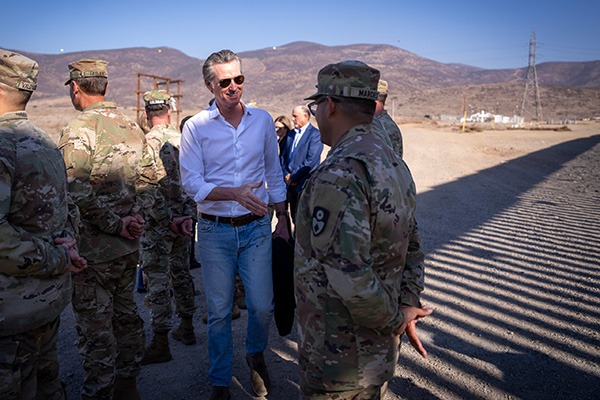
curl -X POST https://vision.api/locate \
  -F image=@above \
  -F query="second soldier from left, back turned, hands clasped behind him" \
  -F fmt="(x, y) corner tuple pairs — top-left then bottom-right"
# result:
(59, 59), (157, 400)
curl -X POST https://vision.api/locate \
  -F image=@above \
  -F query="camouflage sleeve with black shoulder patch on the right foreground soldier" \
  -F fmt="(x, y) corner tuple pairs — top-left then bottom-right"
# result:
(311, 159), (402, 334)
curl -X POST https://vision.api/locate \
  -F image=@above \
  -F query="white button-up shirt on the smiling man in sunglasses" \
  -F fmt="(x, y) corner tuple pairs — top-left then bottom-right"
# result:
(179, 104), (286, 217)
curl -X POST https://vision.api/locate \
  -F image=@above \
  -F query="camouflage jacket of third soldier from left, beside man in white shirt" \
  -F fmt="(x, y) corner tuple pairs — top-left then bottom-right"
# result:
(146, 124), (196, 236)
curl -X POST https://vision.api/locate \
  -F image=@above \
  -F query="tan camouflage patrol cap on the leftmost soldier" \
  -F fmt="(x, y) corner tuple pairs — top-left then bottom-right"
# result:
(0, 49), (40, 92)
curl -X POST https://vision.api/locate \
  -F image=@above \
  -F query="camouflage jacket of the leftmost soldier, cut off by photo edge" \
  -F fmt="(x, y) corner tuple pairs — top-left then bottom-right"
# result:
(0, 111), (73, 336)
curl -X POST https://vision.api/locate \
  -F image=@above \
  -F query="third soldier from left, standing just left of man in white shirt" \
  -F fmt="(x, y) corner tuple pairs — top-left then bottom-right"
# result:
(140, 90), (196, 364)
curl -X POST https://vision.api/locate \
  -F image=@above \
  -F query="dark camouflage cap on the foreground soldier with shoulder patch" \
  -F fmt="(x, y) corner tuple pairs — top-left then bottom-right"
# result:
(304, 60), (379, 101)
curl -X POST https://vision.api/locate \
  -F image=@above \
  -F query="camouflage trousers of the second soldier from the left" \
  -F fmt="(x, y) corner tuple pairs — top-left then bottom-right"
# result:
(73, 251), (145, 399)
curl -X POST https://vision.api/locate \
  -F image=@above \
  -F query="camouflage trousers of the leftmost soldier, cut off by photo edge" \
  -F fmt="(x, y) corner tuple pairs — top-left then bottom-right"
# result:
(0, 317), (66, 400)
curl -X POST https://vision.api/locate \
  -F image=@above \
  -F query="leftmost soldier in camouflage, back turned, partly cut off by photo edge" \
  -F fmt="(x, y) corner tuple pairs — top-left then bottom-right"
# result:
(0, 49), (86, 400)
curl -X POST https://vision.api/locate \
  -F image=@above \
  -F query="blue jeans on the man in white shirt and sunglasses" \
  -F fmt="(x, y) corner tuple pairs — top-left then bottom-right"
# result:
(197, 215), (273, 386)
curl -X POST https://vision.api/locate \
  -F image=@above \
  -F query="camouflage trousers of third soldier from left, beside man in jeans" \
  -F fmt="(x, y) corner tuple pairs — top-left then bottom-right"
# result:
(140, 233), (196, 332)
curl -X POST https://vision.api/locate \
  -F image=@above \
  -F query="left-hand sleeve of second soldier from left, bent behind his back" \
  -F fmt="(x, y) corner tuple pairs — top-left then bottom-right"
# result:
(58, 125), (121, 234)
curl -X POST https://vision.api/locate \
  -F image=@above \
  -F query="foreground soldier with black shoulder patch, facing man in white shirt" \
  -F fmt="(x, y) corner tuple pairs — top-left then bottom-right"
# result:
(294, 61), (431, 399)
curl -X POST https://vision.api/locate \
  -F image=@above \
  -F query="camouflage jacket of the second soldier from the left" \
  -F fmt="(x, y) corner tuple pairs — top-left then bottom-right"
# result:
(59, 102), (157, 264)
